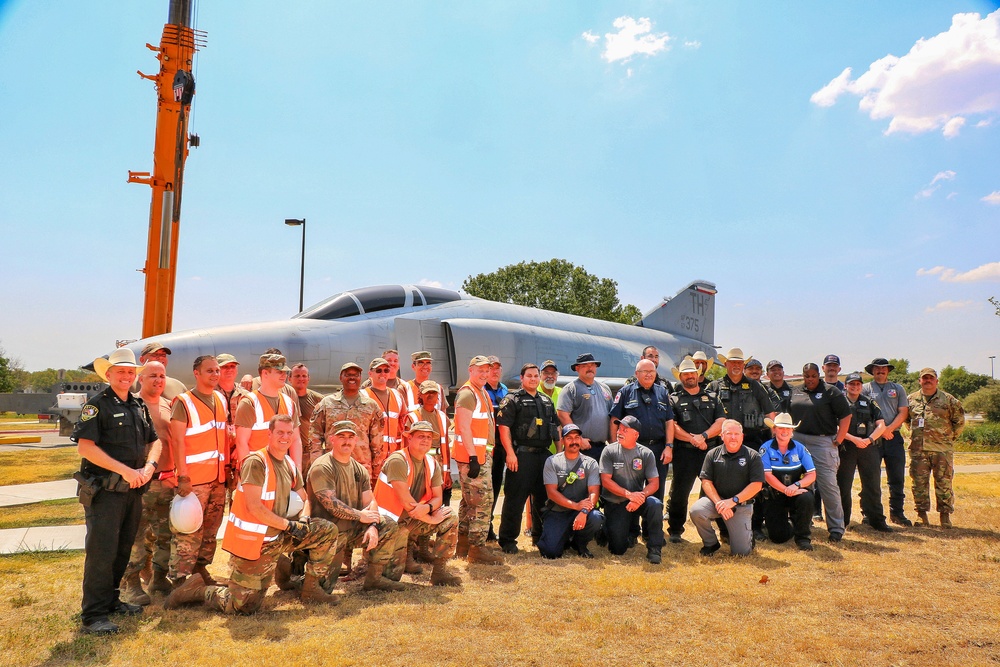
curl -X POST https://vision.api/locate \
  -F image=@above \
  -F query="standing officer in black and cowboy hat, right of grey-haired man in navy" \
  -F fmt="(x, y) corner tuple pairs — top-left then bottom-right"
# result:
(667, 359), (726, 544)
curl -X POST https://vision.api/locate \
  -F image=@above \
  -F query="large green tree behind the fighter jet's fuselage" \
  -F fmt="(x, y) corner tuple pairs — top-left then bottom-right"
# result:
(462, 259), (642, 324)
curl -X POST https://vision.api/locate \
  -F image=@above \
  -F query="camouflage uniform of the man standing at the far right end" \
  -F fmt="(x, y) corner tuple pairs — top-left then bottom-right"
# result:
(907, 389), (965, 514)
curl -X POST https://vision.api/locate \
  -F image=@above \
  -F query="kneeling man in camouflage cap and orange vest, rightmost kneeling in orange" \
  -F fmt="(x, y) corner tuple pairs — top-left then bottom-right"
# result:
(375, 421), (462, 586)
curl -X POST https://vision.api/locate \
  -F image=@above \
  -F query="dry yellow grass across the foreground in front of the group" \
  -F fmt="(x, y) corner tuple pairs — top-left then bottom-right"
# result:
(0, 473), (1000, 667)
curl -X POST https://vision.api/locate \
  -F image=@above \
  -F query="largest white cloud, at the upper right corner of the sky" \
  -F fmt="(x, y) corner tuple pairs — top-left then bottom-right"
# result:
(810, 10), (1000, 138)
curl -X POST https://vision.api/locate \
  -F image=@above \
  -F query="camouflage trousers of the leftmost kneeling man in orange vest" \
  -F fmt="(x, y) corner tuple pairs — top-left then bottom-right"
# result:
(205, 519), (338, 614)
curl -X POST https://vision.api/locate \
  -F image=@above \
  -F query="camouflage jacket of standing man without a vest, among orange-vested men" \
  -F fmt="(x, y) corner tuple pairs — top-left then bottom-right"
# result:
(309, 391), (387, 486)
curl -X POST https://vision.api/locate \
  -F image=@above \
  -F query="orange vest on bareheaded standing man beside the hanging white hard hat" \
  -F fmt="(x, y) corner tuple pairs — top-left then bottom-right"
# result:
(177, 390), (229, 484)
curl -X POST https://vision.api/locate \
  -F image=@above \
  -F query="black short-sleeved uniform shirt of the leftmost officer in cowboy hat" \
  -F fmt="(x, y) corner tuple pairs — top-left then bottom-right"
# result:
(70, 387), (157, 476)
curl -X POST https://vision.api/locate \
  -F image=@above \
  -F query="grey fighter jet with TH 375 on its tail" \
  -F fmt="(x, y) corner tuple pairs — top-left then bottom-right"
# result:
(117, 281), (716, 391)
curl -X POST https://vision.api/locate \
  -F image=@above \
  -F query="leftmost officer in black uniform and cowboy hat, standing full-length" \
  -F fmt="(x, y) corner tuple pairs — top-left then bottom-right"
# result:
(70, 348), (160, 634)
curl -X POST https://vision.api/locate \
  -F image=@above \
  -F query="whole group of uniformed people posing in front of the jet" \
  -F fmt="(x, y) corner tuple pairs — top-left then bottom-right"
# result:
(72, 343), (963, 634)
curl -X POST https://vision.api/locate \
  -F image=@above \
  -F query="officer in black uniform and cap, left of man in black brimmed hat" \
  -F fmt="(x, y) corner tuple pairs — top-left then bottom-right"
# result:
(837, 371), (892, 533)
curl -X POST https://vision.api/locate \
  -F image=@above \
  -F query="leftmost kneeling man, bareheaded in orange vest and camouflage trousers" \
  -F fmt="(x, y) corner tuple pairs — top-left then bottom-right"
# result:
(165, 415), (338, 614)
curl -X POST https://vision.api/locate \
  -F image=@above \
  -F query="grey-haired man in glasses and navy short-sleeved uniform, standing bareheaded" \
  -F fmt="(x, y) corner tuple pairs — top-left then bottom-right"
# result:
(610, 359), (674, 502)
